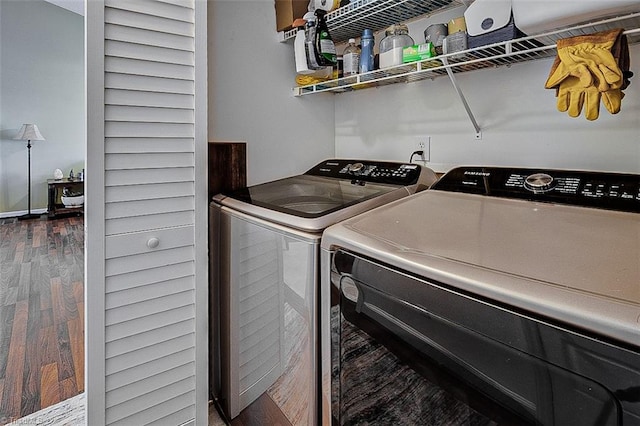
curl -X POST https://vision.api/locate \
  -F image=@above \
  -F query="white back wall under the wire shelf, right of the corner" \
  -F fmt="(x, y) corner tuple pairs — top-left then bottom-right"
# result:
(335, 7), (640, 173)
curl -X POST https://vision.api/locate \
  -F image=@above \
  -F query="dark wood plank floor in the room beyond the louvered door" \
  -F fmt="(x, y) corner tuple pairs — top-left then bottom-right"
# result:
(0, 216), (84, 425)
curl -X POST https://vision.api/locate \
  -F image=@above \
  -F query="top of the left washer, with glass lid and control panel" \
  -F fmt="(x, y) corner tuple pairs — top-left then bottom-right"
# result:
(213, 159), (436, 232)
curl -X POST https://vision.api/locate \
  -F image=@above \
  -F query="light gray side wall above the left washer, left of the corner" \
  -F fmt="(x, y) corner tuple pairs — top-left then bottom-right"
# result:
(209, 0), (335, 185)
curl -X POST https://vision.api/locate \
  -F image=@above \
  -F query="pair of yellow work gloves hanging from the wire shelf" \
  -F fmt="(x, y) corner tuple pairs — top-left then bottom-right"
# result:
(545, 29), (633, 120)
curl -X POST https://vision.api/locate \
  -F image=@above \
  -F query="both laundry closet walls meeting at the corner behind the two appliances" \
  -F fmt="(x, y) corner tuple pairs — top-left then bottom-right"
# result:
(209, 0), (640, 180)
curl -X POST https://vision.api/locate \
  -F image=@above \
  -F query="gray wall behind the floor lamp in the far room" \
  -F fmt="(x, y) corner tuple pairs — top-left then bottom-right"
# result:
(0, 0), (85, 216)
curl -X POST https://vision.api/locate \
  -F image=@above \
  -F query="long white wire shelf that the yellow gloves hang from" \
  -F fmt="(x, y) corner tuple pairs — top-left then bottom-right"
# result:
(294, 12), (640, 96)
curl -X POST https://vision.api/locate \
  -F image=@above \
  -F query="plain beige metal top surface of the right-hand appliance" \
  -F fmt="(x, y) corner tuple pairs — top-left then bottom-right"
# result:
(322, 190), (640, 347)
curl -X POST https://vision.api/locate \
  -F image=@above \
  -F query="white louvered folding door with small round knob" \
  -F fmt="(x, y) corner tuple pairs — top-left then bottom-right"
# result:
(86, 0), (208, 425)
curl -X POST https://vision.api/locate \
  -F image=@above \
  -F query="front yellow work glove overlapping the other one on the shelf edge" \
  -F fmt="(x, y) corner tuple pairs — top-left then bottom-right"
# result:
(545, 28), (623, 92)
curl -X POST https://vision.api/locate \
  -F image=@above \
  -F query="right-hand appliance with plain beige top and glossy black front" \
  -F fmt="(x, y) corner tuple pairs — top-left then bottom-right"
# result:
(322, 167), (640, 425)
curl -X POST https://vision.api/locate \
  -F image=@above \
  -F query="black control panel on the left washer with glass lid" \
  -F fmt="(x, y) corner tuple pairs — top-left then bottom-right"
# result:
(305, 159), (422, 186)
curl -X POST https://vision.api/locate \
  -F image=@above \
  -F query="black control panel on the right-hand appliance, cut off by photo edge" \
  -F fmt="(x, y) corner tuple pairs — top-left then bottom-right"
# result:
(431, 167), (640, 213)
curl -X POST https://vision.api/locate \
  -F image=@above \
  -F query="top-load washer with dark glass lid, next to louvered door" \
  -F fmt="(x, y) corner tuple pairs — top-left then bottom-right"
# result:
(210, 159), (436, 425)
